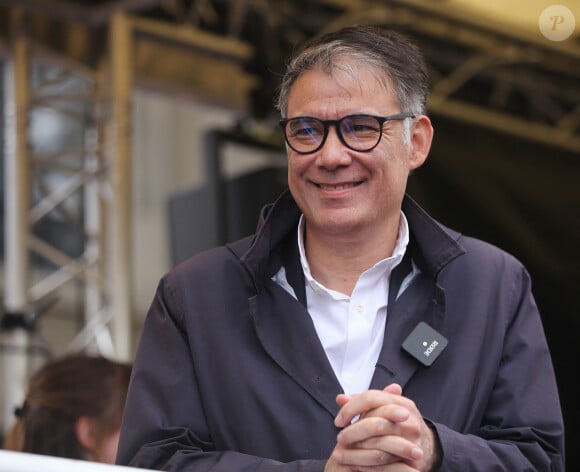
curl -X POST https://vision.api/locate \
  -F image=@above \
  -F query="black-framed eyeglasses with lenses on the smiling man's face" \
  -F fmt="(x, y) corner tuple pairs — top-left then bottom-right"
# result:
(280, 112), (415, 154)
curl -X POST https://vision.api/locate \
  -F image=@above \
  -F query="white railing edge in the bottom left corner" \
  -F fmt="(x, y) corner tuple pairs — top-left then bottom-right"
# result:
(0, 451), (156, 472)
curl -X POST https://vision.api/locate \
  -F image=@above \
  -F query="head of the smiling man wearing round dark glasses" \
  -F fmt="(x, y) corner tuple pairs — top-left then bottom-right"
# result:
(277, 26), (433, 242)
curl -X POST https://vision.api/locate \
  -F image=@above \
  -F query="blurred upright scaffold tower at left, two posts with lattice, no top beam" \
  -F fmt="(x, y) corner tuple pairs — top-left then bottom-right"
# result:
(0, 9), (132, 431)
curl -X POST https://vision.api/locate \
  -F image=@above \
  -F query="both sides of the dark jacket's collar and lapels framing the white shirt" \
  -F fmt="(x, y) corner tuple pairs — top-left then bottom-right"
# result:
(241, 192), (464, 406)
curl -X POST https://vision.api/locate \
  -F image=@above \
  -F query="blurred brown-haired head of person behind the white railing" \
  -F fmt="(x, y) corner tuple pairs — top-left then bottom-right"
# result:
(4, 354), (131, 464)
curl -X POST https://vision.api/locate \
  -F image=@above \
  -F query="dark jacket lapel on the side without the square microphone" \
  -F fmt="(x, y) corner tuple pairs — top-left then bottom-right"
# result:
(241, 197), (342, 417)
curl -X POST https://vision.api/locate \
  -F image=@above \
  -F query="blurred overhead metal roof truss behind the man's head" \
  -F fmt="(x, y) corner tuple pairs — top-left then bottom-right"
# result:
(0, 0), (580, 153)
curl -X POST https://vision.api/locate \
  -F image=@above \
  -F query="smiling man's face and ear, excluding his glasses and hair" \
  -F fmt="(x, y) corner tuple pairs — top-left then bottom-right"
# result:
(287, 63), (431, 238)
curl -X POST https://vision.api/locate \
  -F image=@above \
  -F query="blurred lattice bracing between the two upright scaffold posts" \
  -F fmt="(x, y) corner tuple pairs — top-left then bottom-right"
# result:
(24, 62), (115, 355)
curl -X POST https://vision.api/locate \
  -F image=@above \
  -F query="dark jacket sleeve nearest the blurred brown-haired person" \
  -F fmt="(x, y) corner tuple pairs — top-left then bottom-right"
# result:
(117, 280), (325, 472)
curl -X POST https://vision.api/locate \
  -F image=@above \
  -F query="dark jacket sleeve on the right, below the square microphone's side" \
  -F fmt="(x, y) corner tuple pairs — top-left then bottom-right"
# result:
(434, 264), (565, 472)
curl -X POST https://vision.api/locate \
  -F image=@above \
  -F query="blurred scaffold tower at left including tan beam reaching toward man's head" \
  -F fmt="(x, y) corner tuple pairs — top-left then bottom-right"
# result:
(0, 0), (255, 431)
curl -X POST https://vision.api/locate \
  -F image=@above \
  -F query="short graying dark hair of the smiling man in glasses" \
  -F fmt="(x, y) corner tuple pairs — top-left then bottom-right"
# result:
(275, 26), (428, 123)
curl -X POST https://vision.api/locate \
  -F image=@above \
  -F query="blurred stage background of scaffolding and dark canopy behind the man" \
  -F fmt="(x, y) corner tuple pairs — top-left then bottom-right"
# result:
(0, 0), (580, 470)
